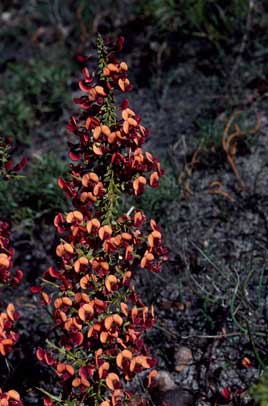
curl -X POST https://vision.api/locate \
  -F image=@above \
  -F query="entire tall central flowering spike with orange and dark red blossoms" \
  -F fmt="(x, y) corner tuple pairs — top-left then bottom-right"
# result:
(33, 36), (166, 406)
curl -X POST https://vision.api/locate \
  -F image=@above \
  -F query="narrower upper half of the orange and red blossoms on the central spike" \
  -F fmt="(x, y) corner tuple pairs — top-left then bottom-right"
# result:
(59, 39), (163, 205)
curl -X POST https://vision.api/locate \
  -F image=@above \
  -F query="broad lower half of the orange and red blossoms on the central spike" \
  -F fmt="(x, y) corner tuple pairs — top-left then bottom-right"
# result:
(36, 210), (165, 405)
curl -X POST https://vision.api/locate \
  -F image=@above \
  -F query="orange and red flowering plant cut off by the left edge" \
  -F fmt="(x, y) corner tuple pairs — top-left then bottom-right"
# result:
(0, 138), (26, 406)
